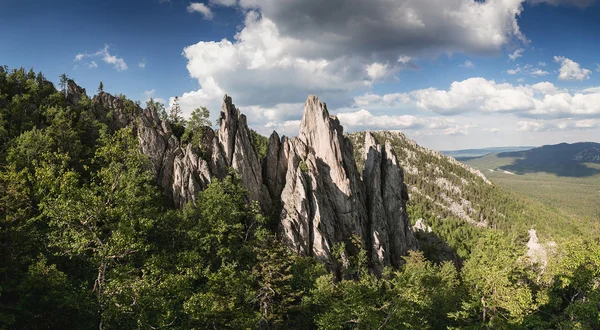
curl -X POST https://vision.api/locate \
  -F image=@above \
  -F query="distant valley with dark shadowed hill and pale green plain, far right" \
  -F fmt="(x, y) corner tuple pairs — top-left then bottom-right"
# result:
(464, 150), (600, 222)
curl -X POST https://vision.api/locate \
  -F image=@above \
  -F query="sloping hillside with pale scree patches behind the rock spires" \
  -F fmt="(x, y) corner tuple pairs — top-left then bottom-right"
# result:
(348, 131), (582, 245)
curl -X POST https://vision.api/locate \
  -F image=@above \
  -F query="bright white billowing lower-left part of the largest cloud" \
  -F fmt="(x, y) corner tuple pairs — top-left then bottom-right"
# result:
(183, 12), (372, 106)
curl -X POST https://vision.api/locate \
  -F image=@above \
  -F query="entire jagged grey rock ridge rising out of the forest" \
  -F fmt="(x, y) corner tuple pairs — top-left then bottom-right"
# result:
(84, 85), (416, 272)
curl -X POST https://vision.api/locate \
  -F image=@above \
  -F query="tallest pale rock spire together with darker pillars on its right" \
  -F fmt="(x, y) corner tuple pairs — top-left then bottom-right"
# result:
(278, 96), (416, 271)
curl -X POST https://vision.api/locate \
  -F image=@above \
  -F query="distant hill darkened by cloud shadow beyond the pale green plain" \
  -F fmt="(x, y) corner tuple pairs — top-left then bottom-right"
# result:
(498, 142), (600, 177)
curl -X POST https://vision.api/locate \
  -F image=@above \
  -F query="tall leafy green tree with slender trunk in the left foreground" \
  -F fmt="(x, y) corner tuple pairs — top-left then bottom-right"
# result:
(36, 129), (163, 325)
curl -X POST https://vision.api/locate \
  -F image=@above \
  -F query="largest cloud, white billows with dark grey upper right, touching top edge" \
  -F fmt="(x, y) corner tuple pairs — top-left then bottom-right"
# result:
(176, 0), (540, 113)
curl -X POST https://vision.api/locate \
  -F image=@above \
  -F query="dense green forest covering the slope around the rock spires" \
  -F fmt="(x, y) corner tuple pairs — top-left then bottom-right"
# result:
(0, 67), (600, 329)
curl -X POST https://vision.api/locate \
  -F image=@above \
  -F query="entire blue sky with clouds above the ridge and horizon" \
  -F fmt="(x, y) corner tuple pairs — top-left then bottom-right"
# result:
(0, 0), (600, 150)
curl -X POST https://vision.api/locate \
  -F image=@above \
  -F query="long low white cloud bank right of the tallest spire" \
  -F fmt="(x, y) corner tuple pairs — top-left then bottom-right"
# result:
(355, 77), (600, 118)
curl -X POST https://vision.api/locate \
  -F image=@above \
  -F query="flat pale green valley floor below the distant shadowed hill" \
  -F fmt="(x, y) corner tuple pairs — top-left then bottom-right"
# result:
(464, 154), (600, 225)
